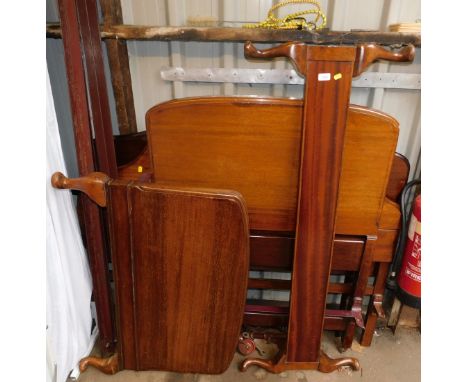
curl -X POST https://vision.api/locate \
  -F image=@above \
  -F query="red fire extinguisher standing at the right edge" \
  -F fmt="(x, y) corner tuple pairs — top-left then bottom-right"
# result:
(396, 195), (421, 309)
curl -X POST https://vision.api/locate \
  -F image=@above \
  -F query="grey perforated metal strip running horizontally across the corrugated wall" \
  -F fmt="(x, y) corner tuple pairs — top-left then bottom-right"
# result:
(161, 67), (421, 90)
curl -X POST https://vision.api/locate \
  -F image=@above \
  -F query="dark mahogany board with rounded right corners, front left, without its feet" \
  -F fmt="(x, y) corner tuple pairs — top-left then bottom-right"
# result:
(108, 181), (249, 374)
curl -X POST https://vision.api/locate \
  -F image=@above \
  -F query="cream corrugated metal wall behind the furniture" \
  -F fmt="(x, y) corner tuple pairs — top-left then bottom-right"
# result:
(122, 0), (421, 176)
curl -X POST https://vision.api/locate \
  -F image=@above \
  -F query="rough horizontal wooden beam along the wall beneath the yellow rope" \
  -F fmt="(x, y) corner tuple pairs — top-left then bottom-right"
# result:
(46, 24), (421, 46)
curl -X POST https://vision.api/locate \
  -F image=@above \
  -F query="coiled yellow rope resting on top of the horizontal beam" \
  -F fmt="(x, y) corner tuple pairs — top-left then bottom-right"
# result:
(243, 0), (327, 30)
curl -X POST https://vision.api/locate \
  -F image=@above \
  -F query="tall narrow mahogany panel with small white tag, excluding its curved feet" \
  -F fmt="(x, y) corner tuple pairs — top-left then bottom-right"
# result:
(287, 46), (355, 362)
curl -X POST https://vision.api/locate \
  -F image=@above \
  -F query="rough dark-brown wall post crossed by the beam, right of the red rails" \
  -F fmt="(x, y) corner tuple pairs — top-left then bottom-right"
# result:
(100, 0), (137, 135)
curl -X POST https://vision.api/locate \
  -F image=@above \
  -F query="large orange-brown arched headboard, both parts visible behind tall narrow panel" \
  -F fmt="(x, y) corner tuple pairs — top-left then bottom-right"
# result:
(146, 97), (398, 234)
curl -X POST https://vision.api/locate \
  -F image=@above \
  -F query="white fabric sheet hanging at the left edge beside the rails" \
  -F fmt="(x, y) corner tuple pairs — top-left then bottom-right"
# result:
(46, 67), (92, 382)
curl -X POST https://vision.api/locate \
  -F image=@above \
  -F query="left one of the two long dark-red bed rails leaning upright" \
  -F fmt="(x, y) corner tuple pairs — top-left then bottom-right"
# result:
(58, 0), (114, 354)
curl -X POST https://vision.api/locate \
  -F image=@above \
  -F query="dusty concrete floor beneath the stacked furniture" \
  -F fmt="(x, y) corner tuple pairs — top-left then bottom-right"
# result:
(78, 327), (421, 382)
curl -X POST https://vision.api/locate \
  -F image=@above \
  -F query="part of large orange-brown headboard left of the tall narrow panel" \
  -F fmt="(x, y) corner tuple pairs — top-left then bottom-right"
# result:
(146, 97), (302, 231)
